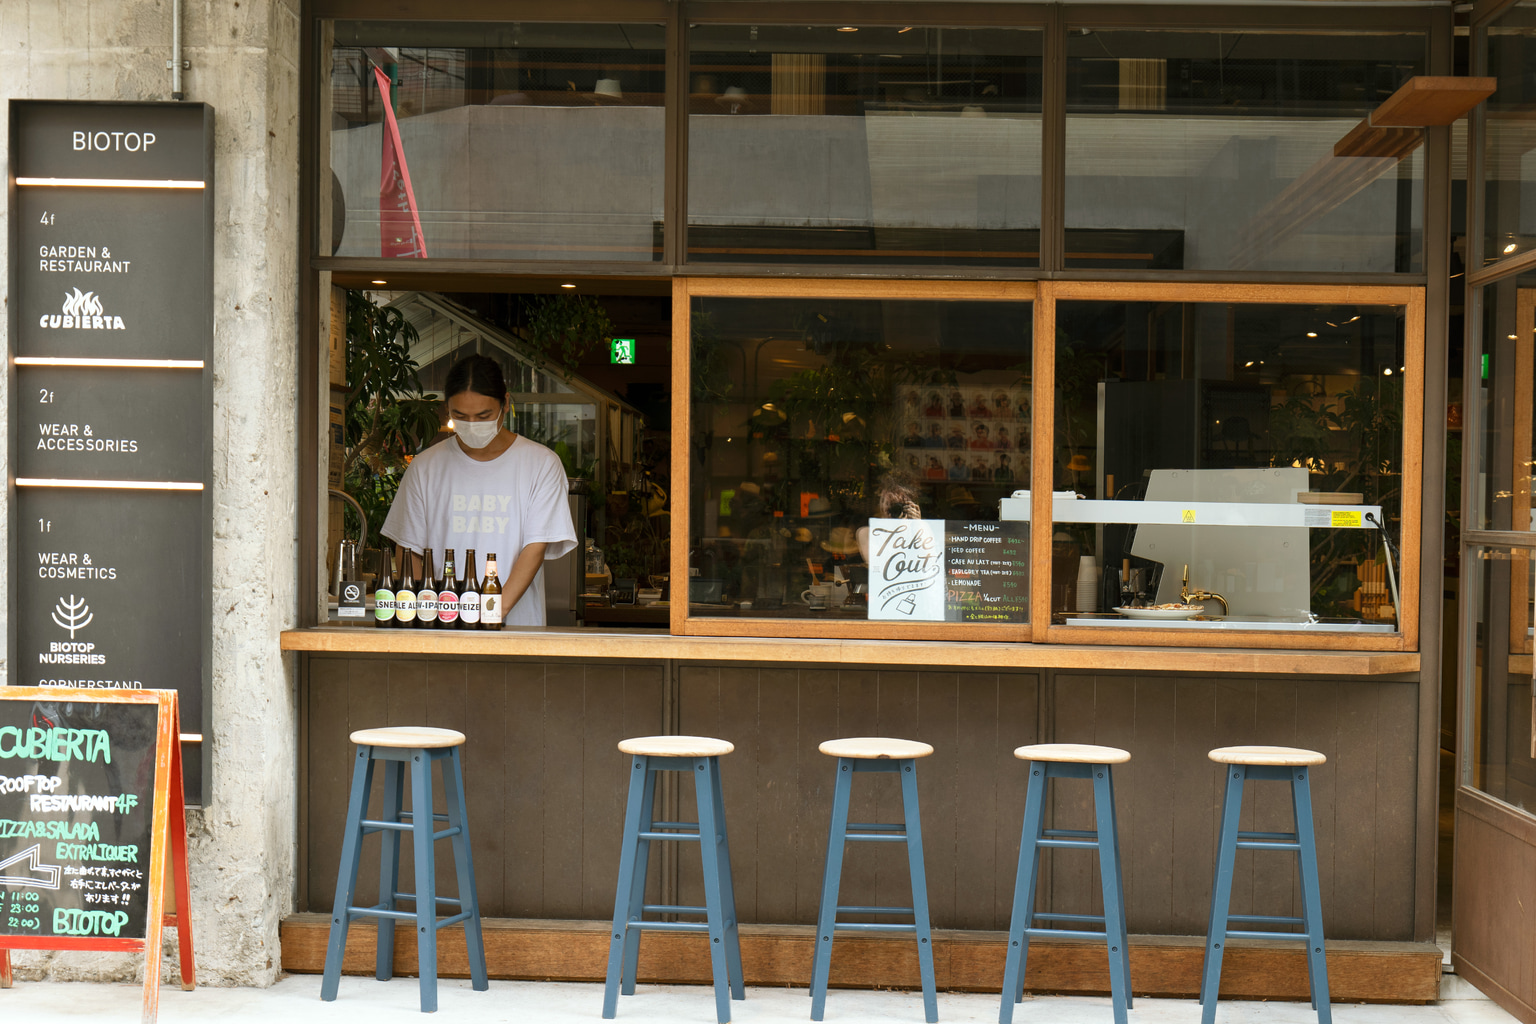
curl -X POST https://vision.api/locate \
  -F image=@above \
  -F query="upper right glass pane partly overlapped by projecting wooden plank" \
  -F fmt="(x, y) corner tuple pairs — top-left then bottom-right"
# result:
(1066, 28), (1424, 273)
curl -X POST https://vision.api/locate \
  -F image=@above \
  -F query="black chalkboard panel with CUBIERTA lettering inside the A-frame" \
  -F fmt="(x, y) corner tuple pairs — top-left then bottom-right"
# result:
(0, 697), (160, 946)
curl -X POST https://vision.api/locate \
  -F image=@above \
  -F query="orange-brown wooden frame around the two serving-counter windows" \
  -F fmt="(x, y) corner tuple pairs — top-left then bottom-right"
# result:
(670, 276), (1425, 651)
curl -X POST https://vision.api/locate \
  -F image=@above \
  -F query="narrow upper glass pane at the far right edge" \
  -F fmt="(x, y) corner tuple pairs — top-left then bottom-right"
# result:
(1475, 3), (1536, 266)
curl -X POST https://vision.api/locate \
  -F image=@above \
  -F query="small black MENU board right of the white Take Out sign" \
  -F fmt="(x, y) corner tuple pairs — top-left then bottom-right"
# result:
(945, 519), (1029, 622)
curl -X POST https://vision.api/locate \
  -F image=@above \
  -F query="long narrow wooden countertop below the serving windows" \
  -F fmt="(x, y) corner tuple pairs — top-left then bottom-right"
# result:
(283, 626), (1419, 676)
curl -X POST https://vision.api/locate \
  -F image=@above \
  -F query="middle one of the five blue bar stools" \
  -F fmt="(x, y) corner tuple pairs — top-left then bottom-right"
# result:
(811, 737), (938, 1024)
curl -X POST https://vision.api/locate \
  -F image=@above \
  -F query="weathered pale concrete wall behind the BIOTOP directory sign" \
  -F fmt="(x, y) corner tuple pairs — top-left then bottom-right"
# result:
(0, 0), (300, 984)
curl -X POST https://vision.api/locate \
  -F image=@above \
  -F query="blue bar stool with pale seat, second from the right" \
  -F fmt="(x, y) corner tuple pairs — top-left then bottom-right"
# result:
(997, 743), (1130, 1024)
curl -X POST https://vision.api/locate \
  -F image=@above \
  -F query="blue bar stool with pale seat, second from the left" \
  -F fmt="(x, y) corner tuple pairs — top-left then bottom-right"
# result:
(602, 735), (746, 1024)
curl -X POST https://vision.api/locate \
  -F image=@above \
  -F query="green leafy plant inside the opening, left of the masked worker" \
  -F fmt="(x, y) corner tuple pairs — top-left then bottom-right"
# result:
(341, 292), (439, 548)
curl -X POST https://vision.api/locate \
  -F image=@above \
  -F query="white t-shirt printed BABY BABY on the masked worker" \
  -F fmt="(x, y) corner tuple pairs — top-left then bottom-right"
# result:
(379, 434), (576, 626)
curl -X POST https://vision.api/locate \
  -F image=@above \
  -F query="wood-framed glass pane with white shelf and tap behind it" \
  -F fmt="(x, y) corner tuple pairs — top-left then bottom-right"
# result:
(1051, 301), (1413, 633)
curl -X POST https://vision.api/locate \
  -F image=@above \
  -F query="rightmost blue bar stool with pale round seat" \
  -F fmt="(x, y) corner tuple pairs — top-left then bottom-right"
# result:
(1200, 746), (1333, 1024)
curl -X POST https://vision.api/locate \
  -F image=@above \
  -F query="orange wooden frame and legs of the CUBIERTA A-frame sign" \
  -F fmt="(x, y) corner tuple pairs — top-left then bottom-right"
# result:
(0, 686), (197, 1024)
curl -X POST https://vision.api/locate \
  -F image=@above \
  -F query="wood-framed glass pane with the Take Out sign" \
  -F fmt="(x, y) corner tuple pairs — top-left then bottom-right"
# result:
(688, 296), (1034, 622)
